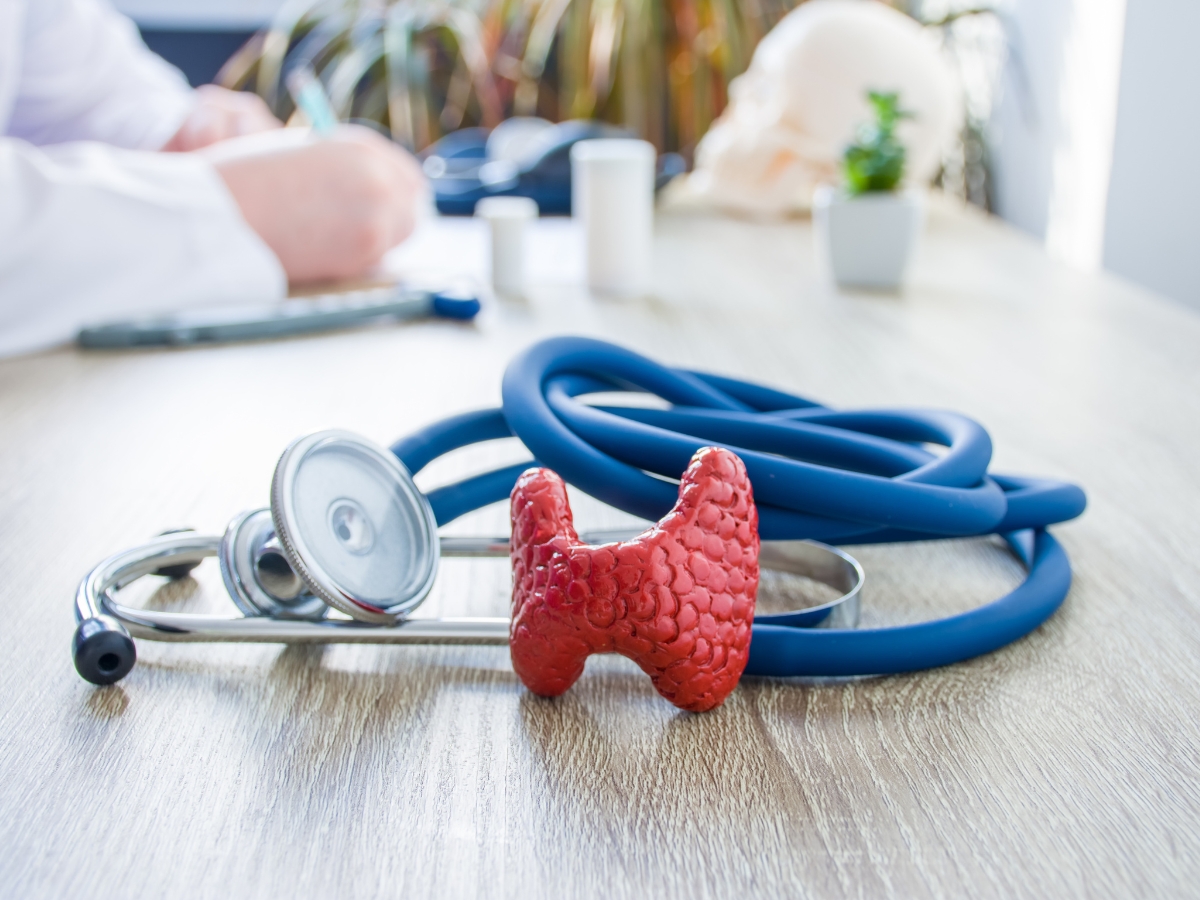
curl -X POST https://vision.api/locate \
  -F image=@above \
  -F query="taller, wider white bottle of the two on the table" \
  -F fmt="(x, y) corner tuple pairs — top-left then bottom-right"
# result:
(571, 138), (656, 296)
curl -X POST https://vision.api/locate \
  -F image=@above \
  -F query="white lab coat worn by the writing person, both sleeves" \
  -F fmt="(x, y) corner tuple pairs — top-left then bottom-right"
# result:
(0, 0), (287, 355)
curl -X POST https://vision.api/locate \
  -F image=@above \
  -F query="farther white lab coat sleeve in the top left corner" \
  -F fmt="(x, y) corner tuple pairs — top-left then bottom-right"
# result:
(7, 0), (196, 150)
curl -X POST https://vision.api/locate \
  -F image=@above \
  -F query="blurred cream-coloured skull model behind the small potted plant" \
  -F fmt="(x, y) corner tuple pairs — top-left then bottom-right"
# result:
(668, 0), (962, 215)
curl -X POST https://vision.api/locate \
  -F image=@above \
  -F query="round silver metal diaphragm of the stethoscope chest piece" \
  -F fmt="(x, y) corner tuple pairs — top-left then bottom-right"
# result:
(271, 431), (438, 625)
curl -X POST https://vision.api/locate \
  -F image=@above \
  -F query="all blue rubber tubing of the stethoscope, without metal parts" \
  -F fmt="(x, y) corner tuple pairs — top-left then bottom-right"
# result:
(392, 337), (1087, 676)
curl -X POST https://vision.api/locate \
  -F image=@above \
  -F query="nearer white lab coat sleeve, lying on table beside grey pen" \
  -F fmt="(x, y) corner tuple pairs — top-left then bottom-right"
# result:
(0, 138), (287, 355)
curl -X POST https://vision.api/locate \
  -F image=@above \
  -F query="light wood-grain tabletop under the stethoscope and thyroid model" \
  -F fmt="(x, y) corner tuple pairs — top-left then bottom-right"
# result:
(0, 200), (1200, 898)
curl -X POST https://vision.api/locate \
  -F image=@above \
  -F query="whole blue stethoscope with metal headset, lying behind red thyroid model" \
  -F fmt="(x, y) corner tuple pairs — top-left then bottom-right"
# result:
(73, 337), (1086, 684)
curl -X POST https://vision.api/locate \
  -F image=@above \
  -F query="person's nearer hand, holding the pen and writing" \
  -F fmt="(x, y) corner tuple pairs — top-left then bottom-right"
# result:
(205, 126), (427, 283)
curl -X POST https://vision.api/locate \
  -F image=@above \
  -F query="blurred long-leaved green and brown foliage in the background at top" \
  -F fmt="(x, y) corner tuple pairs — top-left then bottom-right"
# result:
(218, 0), (1003, 204)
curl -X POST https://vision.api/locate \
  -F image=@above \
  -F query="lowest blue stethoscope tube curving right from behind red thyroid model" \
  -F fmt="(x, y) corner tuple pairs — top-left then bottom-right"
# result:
(745, 530), (1070, 677)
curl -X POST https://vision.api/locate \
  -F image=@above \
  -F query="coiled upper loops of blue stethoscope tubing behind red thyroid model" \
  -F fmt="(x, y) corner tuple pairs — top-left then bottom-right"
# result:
(496, 337), (1086, 544)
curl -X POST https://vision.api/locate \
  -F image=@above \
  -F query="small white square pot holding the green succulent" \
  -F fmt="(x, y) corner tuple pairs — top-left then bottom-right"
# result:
(812, 185), (925, 289)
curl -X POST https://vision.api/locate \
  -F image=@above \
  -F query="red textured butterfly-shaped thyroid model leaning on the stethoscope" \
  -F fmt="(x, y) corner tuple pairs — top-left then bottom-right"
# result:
(510, 448), (758, 713)
